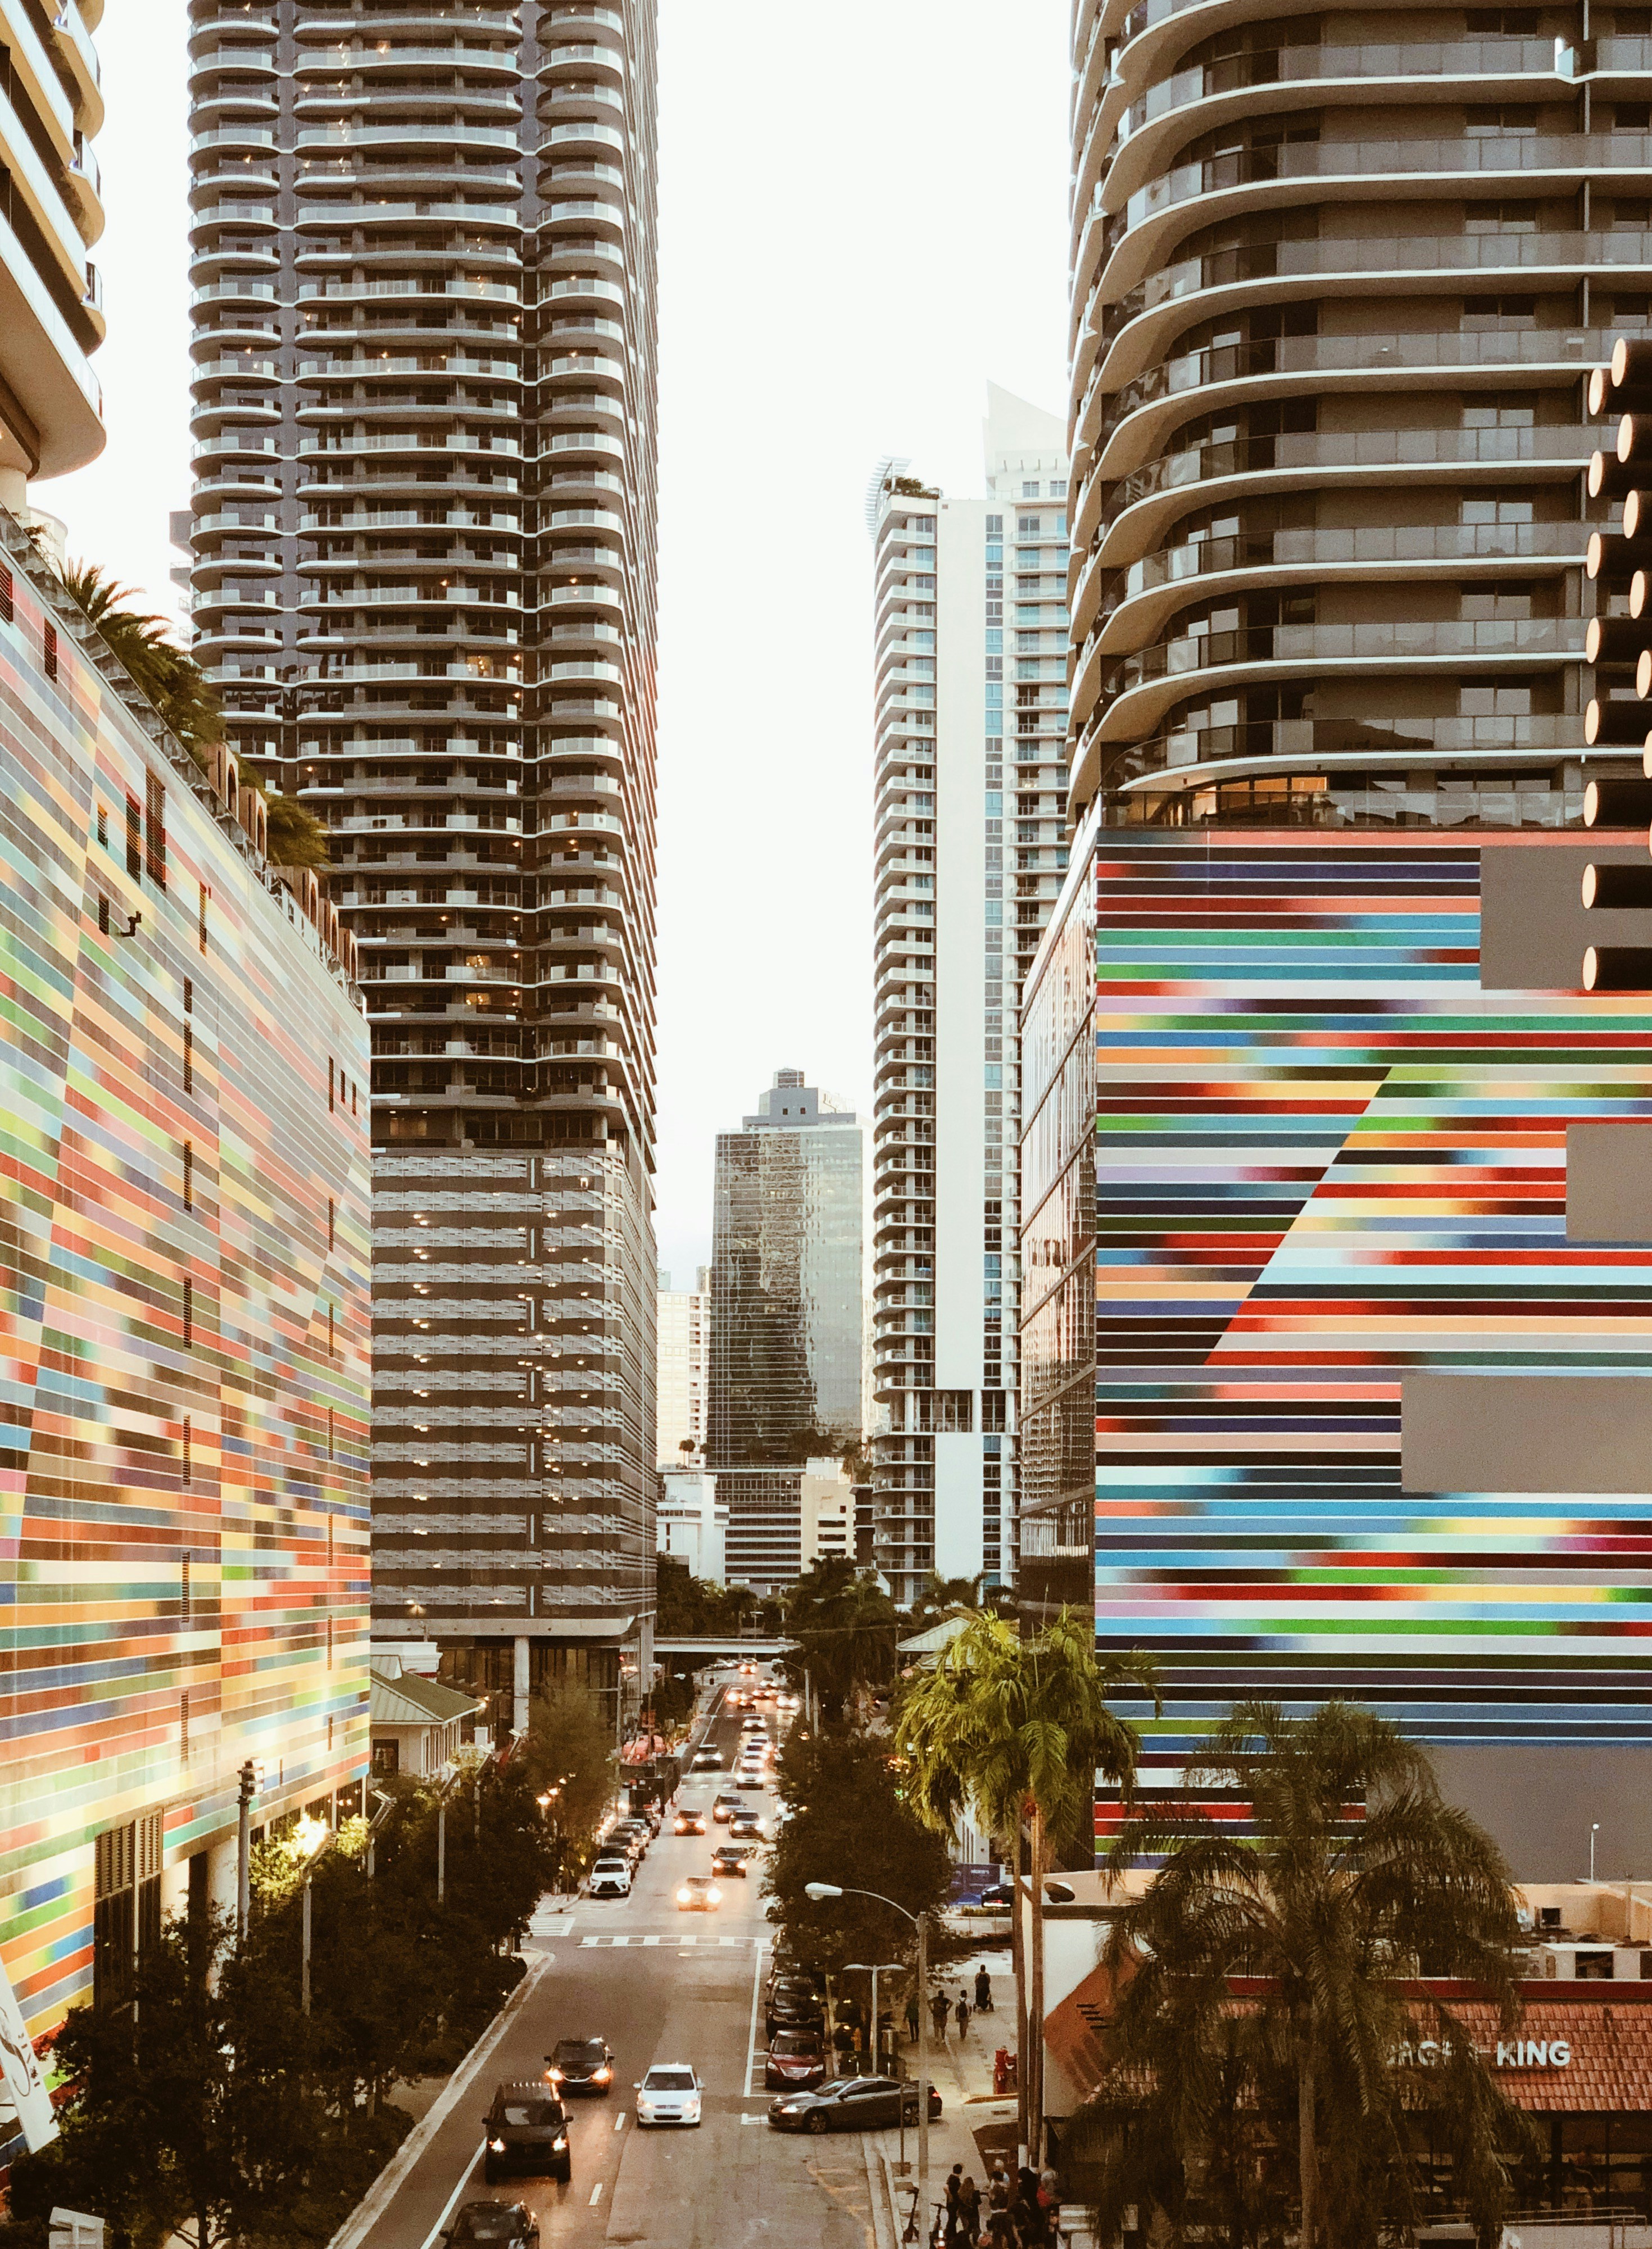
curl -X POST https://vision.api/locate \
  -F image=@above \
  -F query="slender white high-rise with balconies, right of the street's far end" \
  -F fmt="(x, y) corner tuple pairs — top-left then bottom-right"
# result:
(869, 387), (1067, 1601)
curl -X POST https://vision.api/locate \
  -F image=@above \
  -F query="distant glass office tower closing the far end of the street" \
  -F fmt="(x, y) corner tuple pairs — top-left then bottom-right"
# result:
(707, 1070), (866, 1583)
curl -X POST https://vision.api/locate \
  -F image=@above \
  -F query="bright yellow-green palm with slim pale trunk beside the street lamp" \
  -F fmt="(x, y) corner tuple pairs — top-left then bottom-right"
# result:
(896, 1608), (1155, 2155)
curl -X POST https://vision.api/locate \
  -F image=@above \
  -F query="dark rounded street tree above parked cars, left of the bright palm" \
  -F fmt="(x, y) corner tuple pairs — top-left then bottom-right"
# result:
(765, 1732), (952, 1973)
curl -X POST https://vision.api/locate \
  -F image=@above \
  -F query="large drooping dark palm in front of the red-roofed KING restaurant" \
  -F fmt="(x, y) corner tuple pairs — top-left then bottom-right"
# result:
(1076, 1702), (1519, 2249)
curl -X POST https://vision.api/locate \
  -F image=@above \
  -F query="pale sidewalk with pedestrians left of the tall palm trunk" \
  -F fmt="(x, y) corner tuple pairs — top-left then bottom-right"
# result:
(866, 1939), (1015, 2249)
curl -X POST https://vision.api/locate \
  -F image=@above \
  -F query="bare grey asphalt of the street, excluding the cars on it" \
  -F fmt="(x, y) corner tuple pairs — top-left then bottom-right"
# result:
(362, 1682), (871, 2249)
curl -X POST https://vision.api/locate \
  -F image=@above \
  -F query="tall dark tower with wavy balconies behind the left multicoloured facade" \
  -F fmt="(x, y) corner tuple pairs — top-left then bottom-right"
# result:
(191, 0), (655, 1720)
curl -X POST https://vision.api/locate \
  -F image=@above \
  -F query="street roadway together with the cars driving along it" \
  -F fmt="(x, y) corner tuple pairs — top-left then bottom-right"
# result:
(360, 1675), (887, 2249)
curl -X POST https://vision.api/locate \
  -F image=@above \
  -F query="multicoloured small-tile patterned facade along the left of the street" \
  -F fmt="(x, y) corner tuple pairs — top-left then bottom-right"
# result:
(0, 533), (369, 2051)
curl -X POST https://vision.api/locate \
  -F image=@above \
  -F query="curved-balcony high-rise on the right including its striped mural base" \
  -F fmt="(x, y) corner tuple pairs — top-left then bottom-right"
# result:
(1022, 4), (1652, 1876)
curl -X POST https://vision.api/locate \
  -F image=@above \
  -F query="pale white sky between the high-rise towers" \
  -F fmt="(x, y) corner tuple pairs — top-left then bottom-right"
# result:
(48, 0), (1069, 1287)
